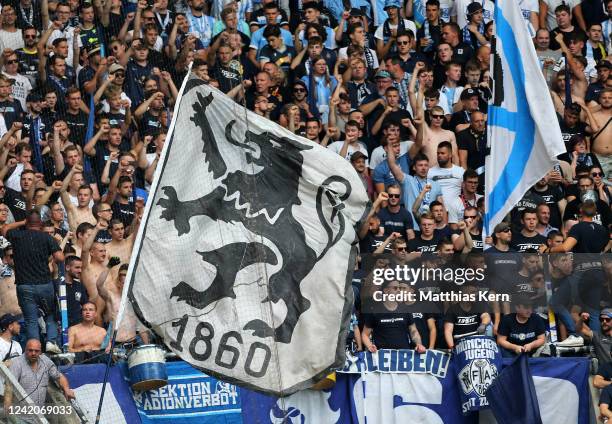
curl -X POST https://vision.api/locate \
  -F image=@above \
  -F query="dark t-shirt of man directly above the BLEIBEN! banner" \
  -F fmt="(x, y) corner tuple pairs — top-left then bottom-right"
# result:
(365, 313), (414, 349)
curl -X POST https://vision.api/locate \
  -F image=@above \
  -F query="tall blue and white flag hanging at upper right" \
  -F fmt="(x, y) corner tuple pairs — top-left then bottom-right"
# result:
(484, 0), (565, 235)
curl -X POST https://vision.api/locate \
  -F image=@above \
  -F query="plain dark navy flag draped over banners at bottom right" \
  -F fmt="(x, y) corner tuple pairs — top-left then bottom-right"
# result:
(487, 354), (542, 424)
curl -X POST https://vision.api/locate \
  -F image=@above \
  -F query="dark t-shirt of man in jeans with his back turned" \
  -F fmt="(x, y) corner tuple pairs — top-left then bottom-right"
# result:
(6, 229), (60, 284)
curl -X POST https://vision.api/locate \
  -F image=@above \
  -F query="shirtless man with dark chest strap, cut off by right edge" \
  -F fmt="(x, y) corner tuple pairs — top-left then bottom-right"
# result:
(586, 88), (612, 179)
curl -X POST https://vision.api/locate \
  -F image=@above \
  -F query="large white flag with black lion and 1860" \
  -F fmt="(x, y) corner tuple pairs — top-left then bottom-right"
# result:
(119, 77), (367, 395)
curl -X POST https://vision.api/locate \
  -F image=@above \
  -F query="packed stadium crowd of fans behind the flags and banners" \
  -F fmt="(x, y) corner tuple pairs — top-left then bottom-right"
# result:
(0, 0), (612, 416)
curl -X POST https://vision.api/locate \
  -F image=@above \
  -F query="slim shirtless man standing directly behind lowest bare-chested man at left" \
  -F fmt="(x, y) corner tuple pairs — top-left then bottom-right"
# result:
(81, 221), (106, 325)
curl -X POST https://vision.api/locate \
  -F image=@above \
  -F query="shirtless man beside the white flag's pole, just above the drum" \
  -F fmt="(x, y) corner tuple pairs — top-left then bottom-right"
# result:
(96, 264), (149, 344)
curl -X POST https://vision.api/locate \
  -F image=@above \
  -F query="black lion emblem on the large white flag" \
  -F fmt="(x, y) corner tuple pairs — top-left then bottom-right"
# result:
(157, 83), (351, 343)
